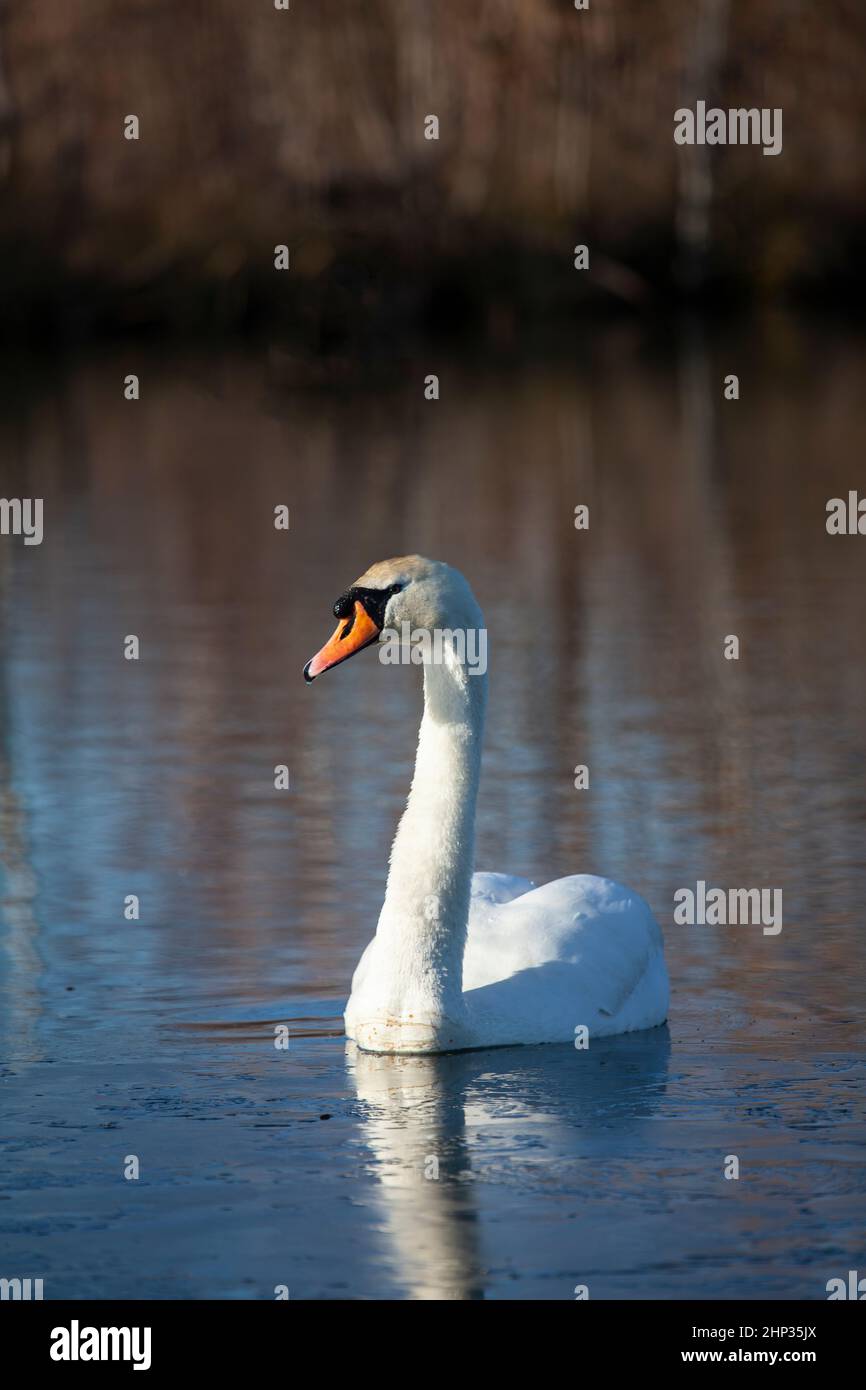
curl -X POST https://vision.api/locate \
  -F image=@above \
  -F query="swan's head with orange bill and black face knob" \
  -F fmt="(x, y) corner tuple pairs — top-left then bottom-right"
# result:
(303, 555), (484, 681)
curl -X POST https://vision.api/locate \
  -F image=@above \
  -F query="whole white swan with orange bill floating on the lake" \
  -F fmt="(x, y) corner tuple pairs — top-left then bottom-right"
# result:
(304, 555), (669, 1054)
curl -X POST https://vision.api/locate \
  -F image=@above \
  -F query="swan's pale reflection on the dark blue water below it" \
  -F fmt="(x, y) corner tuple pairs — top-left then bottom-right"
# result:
(346, 1027), (670, 1300)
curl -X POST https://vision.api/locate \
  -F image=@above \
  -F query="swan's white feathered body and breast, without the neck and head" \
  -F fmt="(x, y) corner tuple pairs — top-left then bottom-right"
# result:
(346, 873), (669, 1052)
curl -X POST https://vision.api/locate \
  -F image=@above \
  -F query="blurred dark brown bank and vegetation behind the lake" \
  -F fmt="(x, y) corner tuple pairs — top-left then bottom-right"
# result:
(0, 0), (866, 344)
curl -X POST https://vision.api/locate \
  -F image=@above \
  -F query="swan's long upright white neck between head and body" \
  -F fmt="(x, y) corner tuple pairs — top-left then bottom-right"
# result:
(375, 650), (487, 1017)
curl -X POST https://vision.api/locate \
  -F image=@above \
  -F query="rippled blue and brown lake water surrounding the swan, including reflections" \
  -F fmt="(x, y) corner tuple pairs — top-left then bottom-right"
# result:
(0, 318), (866, 1300)
